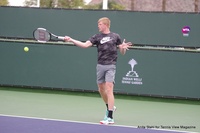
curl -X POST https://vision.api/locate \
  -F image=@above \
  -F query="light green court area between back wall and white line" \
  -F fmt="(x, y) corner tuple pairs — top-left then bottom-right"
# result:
(0, 87), (200, 132)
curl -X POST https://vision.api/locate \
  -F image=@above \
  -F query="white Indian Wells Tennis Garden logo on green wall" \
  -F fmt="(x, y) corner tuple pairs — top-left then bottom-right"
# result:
(122, 59), (142, 85)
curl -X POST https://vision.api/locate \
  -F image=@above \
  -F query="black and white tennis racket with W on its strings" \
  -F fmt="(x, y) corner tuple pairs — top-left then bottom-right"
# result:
(33, 28), (64, 43)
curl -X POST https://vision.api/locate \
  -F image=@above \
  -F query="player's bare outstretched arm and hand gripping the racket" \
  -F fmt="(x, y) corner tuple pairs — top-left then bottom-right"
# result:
(64, 36), (92, 48)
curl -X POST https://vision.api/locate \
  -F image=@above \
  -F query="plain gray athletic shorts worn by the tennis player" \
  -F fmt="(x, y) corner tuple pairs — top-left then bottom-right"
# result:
(96, 64), (116, 84)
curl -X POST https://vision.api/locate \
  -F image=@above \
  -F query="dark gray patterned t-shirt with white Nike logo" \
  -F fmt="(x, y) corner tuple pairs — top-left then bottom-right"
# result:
(89, 32), (122, 65)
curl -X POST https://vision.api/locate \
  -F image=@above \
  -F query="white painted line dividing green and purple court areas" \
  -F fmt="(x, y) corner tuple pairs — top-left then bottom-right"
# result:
(0, 114), (198, 133)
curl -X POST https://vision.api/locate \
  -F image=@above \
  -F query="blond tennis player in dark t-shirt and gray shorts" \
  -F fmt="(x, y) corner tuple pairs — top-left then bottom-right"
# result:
(64, 17), (132, 125)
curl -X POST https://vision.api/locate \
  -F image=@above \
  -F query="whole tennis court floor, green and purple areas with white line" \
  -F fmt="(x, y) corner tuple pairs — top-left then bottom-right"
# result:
(0, 87), (200, 133)
